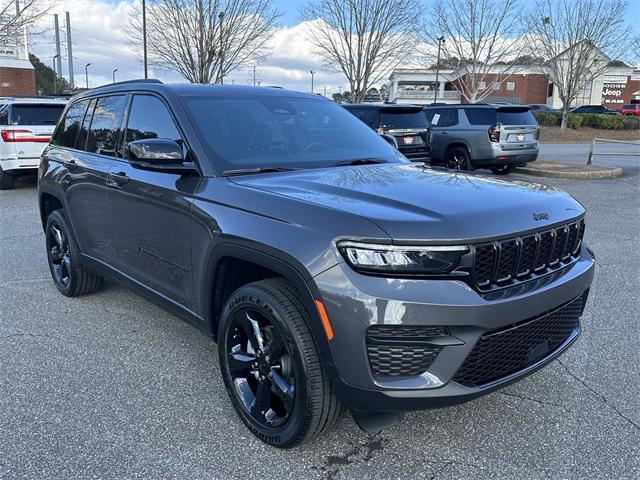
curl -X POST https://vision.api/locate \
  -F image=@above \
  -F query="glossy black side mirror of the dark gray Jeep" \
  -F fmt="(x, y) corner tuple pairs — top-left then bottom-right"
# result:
(127, 138), (197, 175)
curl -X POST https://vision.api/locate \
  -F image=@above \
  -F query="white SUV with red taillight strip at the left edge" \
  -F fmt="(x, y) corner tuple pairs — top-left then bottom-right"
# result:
(0, 97), (66, 190)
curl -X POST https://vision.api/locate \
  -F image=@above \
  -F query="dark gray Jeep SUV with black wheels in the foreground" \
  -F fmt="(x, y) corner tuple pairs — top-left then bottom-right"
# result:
(38, 81), (594, 447)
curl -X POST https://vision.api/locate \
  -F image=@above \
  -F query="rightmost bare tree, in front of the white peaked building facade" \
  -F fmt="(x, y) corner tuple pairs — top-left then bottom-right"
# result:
(527, 0), (631, 129)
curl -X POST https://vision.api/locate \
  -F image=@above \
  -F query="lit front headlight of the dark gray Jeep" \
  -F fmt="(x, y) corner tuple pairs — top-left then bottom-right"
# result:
(338, 241), (469, 275)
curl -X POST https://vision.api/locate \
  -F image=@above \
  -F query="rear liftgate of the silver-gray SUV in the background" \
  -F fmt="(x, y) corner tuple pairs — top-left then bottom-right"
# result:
(496, 107), (538, 150)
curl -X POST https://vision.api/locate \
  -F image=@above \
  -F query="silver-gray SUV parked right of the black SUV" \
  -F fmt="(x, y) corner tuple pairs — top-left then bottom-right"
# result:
(425, 104), (540, 174)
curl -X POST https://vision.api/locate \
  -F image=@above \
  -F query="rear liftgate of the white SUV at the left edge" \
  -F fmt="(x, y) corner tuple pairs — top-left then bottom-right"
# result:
(2, 103), (64, 167)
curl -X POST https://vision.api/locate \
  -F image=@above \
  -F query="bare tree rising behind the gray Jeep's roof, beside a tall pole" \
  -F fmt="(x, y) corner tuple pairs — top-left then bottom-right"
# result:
(129, 0), (280, 83)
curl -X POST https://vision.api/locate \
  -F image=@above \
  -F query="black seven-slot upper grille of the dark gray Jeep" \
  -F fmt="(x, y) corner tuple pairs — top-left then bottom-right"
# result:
(474, 220), (584, 291)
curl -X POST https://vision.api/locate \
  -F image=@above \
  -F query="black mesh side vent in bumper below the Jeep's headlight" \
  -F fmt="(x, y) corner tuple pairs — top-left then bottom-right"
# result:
(367, 325), (448, 377)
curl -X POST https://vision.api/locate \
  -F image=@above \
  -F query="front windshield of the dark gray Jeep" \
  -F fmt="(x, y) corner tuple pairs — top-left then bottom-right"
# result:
(183, 96), (406, 171)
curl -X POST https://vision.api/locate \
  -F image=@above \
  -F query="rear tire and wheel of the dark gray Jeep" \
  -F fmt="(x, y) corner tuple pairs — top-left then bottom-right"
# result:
(45, 210), (103, 297)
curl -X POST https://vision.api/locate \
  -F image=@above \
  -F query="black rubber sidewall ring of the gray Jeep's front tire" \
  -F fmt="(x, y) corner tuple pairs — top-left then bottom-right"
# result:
(218, 285), (309, 447)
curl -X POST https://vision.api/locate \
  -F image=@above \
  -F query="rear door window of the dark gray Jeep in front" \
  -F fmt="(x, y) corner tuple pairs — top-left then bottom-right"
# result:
(86, 95), (127, 157)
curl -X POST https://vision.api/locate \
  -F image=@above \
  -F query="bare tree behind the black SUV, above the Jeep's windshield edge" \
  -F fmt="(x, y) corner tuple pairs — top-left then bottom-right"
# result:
(302, 0), (421, 102)
